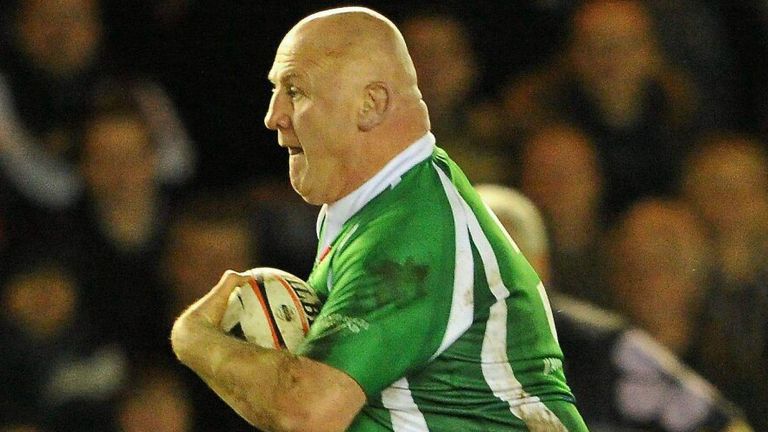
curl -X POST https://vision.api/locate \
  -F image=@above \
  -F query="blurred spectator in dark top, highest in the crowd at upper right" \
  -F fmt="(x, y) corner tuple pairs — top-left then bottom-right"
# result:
(505, 0), (698, 222)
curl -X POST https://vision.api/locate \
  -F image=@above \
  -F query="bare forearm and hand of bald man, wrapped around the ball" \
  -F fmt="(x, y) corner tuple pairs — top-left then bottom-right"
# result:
(171, 272), (365, 432)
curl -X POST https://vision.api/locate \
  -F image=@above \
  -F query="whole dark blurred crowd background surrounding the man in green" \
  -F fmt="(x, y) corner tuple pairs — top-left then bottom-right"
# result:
(0, 0), (768, 432)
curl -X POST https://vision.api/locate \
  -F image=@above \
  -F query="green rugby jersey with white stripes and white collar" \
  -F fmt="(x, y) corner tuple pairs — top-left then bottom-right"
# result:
(298, 134), (586, 432)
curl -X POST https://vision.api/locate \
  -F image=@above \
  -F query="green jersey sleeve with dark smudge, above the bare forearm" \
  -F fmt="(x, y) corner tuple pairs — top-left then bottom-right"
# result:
(299, 208), (454, 396)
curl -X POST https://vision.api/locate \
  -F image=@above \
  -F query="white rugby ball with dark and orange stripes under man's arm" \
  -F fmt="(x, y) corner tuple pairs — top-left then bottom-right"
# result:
(221, 267), (321, 351)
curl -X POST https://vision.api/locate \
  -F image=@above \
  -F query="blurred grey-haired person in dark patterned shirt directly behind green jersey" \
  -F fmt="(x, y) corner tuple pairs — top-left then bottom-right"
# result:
(478, 185), (752, 432)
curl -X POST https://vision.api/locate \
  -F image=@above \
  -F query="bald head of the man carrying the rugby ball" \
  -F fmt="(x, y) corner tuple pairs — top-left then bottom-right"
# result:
(264, 7), (429, 204)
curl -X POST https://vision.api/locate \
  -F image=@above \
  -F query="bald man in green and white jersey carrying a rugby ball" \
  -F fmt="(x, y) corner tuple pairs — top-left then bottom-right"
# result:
(172, 8), (586, 432)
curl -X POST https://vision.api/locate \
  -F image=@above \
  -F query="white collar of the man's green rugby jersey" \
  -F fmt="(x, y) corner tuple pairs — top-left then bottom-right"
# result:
(317, 132), (435, 248)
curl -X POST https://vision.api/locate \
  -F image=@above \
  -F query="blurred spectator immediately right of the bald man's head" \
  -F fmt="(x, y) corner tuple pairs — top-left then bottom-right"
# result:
(400, 13), (513, 182)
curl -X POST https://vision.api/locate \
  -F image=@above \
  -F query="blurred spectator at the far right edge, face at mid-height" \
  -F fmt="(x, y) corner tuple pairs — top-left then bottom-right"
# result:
(682, 133), (768, 430)
